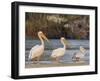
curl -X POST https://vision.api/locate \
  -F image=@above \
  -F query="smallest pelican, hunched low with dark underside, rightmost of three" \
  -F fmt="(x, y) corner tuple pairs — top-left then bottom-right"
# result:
(72, 46), (86, 62)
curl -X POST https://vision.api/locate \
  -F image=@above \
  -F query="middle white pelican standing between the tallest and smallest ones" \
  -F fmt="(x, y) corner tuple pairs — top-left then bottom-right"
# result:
(51, 37), (68, 63)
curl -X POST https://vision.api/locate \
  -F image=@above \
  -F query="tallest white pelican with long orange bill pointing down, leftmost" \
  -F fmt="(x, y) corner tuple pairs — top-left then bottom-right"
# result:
(29, 31), (49, 62)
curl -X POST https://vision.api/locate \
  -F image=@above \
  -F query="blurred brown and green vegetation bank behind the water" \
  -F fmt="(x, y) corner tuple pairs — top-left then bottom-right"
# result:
(25, 12), (89, 39)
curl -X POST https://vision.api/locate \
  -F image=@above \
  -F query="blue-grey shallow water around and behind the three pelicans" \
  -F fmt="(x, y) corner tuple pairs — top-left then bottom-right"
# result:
(25, 39), (89, 64)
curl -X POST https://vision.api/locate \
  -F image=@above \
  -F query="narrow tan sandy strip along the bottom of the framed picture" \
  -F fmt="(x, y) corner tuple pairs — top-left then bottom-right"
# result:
(25, 62), (89, 68)
